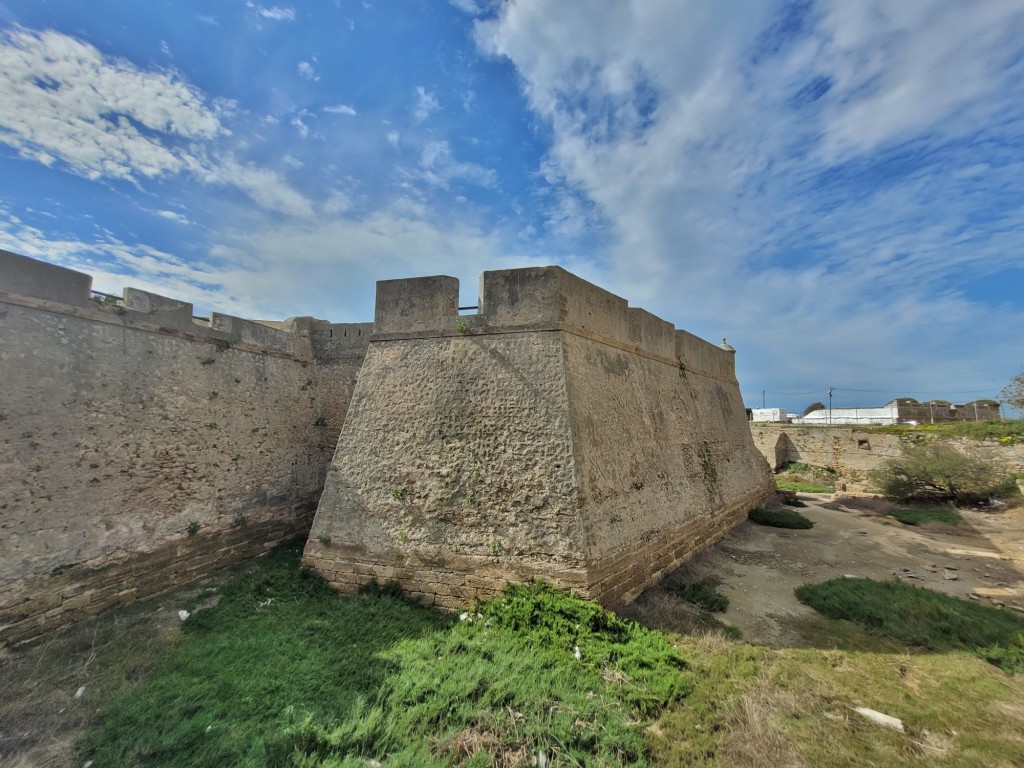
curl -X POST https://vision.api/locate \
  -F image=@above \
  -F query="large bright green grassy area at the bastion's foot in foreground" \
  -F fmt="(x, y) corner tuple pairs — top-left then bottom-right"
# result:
(80, 545), (692, 768)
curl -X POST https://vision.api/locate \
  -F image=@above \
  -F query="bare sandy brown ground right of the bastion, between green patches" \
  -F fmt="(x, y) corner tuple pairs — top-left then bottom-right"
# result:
(663, 494), (1024, 646)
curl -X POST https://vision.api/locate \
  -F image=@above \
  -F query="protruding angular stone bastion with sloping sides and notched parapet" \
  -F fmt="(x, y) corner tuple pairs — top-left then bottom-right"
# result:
(304, 267), (774, 607)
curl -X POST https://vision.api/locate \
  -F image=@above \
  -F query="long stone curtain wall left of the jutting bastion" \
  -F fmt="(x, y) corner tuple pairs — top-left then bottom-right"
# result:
(0, 251), (373, 643)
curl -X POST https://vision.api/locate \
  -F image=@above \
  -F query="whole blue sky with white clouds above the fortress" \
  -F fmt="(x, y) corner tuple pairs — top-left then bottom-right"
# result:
(0, 0), (1024, 410)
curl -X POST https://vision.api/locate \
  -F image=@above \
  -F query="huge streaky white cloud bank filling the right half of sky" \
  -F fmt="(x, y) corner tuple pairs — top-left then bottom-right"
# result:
(475, 0), (1024, 405)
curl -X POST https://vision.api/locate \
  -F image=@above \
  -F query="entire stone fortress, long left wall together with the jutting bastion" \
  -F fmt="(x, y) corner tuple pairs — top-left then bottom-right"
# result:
(0, 251), (773, 644)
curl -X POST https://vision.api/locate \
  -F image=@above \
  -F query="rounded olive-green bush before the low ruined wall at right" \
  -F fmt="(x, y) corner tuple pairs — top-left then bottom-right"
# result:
(868, 443), (1007, 504)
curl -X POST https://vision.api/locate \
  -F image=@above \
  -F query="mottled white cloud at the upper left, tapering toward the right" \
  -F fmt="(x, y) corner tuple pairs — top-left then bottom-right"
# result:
(0, 28), (312, 216)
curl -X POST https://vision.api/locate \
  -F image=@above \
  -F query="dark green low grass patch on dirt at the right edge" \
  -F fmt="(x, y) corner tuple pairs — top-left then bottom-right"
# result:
(796, 579), (1024, 672)
